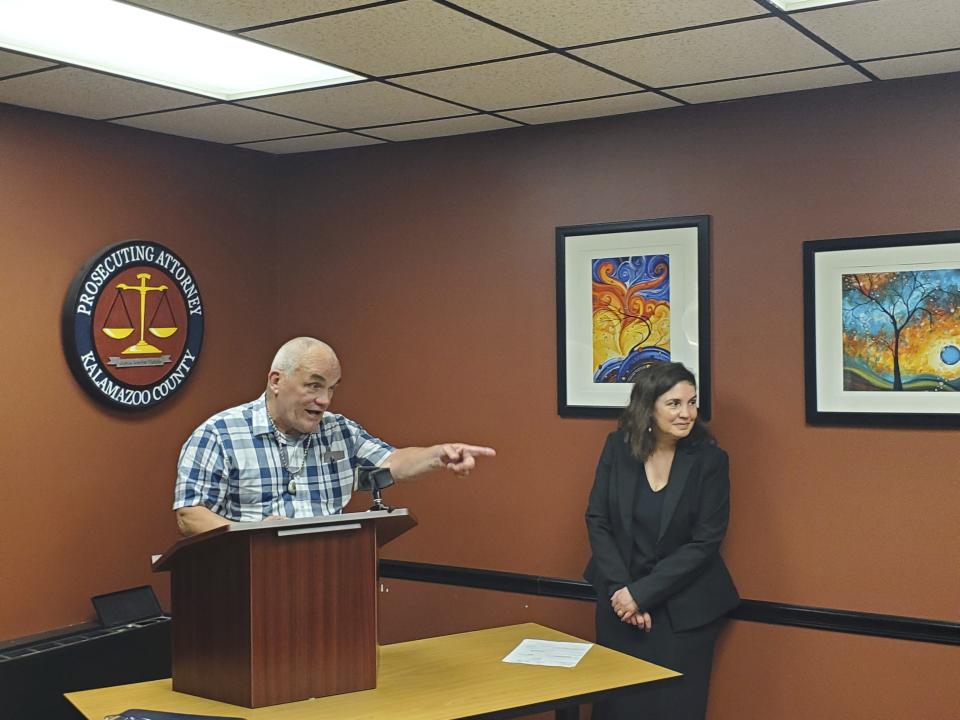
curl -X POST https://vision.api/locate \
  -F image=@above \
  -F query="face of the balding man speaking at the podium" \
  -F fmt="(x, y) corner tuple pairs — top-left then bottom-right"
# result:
(267, 348), (340, 435)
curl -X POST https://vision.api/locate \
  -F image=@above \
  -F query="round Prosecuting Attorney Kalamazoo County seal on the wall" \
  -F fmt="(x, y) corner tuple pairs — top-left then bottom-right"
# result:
(62, 240), (203, 410)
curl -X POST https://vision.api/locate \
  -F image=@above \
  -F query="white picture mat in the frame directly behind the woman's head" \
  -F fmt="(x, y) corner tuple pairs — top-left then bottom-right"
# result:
(564, 226), (700, 407)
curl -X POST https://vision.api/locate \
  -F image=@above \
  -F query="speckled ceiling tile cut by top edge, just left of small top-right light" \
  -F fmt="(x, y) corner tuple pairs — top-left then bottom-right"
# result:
(455, 0), (768, 47)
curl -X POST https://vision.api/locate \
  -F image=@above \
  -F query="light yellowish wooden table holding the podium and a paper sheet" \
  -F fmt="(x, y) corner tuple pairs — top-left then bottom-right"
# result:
(66, 623), (678, 720)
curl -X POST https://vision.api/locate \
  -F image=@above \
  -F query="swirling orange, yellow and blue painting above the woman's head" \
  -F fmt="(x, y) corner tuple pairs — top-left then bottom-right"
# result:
(591, 255), (670, 383)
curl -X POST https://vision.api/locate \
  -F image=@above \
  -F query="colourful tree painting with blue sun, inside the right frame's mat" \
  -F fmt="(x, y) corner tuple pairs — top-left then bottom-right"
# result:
(841, 268), (960, 392)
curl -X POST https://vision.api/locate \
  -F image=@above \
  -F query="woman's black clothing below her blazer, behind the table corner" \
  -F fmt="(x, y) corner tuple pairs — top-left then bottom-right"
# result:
(593, 600), (723, 720)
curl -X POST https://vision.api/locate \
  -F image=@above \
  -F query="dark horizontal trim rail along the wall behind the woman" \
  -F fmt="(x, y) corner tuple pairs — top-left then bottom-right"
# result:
(380, 560), (960, 645)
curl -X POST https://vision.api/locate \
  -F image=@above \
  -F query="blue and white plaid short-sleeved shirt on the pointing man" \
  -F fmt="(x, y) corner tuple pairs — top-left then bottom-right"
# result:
(173, 395), (394, 522)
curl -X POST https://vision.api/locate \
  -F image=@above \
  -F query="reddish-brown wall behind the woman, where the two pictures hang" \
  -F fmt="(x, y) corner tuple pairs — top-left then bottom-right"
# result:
(279, 76), (960, 720)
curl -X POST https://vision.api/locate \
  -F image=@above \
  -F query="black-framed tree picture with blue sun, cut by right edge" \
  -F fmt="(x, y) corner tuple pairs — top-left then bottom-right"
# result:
(803, 231), (960, 427)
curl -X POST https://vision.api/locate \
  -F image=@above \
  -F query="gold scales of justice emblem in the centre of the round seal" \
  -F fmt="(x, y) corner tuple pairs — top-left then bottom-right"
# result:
(100, 272), (179, 367)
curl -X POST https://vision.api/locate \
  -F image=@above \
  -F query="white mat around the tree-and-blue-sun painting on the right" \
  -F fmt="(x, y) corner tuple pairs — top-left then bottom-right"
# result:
(814, 243), (960, 413)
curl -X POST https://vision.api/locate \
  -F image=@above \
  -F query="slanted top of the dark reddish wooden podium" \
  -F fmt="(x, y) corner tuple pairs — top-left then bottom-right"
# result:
(153, 508), (417, 572)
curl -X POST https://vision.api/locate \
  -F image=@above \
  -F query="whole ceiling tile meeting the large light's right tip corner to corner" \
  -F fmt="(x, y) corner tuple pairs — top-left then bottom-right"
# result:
(395, 55), (637, 110)
